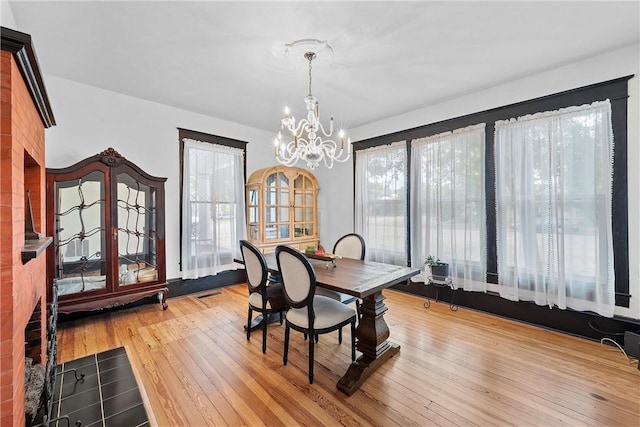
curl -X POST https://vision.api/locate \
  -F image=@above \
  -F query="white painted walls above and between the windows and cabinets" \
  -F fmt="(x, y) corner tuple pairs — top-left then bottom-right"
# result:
(38, 41), (640, 318)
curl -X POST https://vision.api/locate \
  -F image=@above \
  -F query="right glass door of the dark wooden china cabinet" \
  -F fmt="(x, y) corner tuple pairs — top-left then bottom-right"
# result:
(114, 173), (158, 286)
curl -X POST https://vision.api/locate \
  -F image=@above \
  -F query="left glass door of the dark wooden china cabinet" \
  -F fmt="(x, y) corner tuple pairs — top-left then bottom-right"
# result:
(53, 171), (109, 295)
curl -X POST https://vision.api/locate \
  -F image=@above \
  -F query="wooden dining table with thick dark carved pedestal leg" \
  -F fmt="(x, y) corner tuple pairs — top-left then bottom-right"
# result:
(252, 253), (420, 396)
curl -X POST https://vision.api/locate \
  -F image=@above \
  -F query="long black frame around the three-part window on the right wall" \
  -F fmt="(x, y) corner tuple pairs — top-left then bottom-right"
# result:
(353, 75), (633, 308)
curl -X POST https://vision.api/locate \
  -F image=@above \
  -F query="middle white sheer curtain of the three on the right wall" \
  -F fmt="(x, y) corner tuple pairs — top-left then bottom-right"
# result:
(411, 123), (487, 292)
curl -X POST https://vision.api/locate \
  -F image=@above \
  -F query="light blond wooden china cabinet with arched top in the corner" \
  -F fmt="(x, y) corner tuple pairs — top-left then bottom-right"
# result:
(247, 166), (319, 253)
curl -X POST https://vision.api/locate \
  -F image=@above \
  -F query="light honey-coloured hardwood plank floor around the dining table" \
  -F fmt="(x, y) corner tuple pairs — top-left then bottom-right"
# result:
(58, 285), (640, 426)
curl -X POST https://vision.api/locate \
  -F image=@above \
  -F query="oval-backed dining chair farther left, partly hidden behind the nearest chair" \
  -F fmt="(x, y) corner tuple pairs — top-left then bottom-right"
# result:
(240, 240), (287, 353)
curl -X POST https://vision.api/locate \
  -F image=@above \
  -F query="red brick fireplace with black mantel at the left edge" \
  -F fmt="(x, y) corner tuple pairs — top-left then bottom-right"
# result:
(0, 27), (55, 426)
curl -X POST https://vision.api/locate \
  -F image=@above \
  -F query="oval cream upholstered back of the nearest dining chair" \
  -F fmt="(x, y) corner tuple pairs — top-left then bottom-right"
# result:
(276, 245), (316, 308)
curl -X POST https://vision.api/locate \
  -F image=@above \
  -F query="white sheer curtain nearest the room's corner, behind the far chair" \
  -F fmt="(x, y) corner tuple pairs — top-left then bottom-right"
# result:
(355, 141), (407, 266)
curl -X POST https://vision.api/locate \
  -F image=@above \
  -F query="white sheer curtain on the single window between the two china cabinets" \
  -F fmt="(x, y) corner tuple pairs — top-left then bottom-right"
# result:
(182, 138), (246, 279)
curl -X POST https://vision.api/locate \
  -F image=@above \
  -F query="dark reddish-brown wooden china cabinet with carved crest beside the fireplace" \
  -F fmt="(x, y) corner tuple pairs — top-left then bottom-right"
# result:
(46, 148), (168, 313)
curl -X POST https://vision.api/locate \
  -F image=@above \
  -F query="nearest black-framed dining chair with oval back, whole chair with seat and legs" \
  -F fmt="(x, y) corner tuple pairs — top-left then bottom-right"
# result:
(276, 246), (356, 384)
